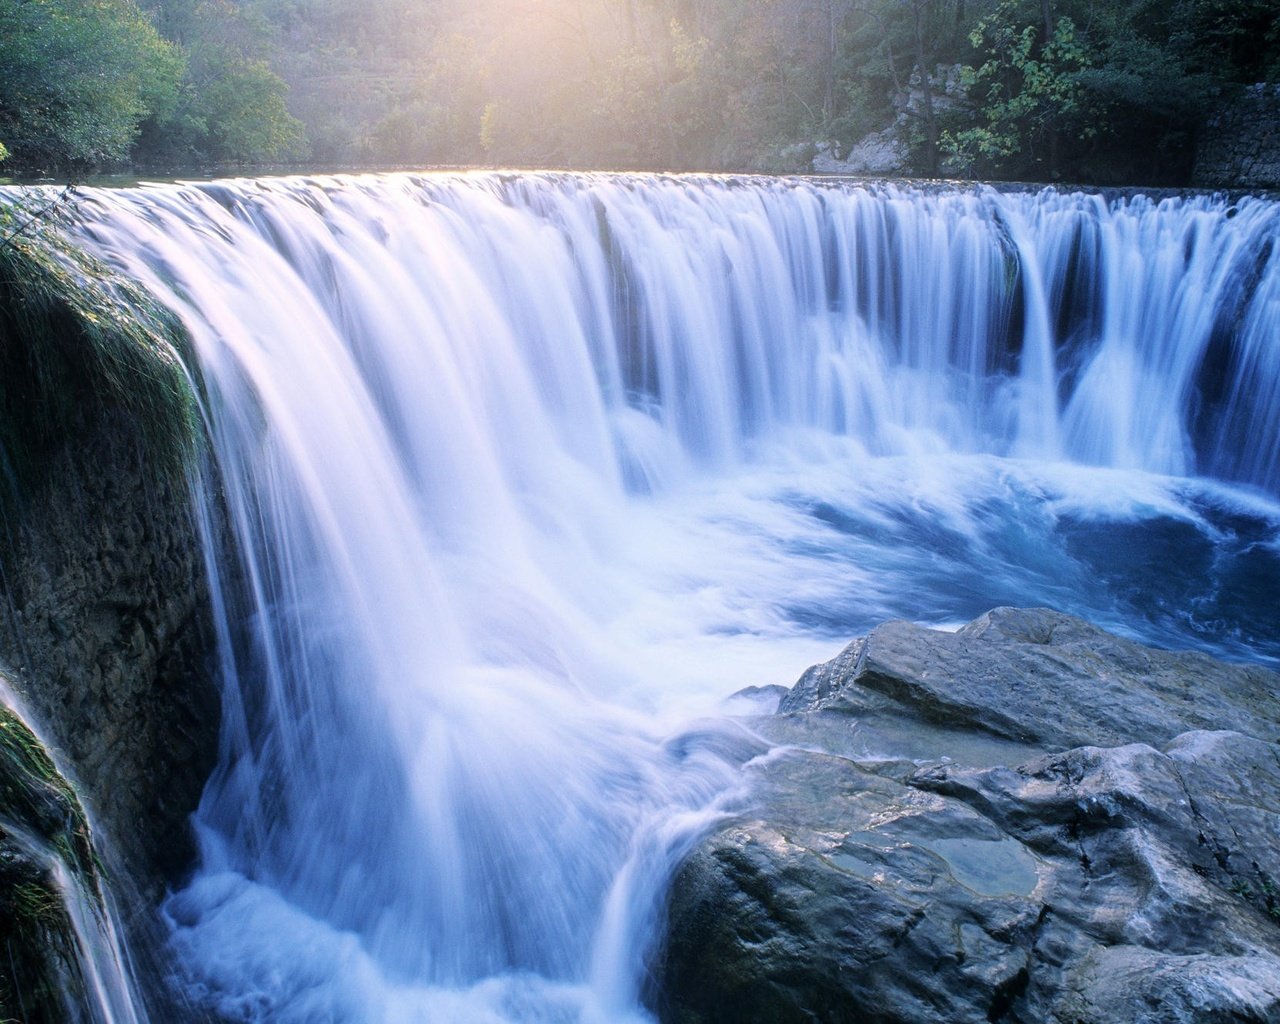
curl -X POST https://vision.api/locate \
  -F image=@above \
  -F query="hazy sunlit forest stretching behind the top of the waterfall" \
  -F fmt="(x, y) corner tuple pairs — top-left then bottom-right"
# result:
(0, 0), (1280, 184)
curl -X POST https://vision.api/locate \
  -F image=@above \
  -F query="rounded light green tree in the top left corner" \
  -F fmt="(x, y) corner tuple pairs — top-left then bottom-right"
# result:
(0, 0), (183, 172)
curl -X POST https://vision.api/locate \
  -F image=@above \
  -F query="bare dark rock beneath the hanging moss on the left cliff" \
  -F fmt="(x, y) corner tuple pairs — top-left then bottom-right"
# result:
(0, 404), (220, 895)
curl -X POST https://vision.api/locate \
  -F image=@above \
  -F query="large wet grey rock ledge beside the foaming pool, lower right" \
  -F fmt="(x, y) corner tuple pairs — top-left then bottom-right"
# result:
(659, 608), (1280, 1024)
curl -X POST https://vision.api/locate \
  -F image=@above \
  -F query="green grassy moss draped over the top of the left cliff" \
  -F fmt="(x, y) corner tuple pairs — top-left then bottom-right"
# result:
(0, 192), (200, 512)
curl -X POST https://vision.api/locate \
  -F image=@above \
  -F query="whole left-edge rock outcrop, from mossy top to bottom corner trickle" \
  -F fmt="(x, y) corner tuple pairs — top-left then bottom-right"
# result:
(0, 203), (220, 1024)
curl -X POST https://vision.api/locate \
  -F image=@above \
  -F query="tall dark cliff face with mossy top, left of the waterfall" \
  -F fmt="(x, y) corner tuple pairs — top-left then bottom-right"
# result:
(0, 188), (220, 921)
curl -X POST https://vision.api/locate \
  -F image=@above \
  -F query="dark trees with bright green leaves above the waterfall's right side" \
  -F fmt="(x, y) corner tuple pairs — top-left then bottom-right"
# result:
(942, 0), (1234, 180)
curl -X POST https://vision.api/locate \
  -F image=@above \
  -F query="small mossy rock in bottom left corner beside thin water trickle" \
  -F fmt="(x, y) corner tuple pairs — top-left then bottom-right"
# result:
(0, 707), (104, 1024)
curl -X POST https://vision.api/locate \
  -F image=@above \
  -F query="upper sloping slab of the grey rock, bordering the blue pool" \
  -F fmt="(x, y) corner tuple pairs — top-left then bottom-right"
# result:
(780, 608), (1280, 750)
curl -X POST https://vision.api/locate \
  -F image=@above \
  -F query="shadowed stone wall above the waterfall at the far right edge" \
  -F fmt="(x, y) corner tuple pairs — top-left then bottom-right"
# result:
(1192, 84), (1280, 188)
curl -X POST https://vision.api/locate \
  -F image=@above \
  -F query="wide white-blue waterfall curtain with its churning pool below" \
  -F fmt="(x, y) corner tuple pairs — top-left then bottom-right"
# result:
(40, 174), (1280, 1021)
